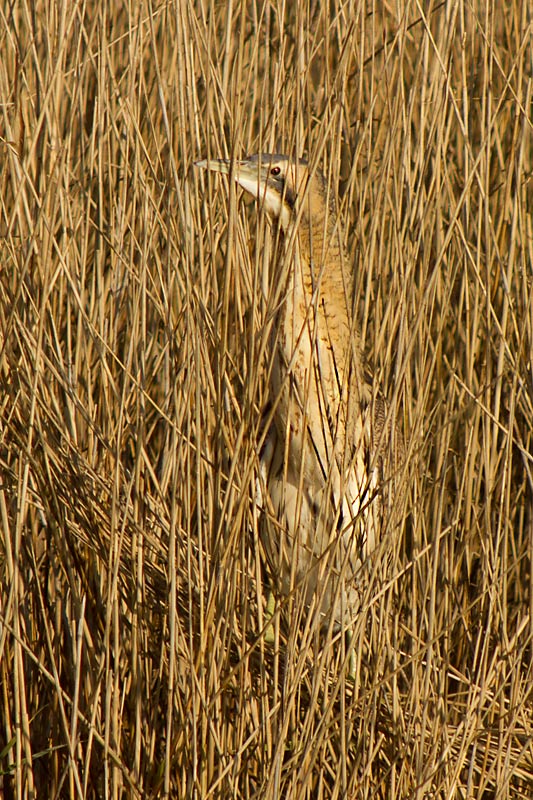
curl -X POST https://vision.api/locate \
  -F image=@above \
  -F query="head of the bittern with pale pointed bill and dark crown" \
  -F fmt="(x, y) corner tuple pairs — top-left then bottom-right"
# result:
(196, 153), (333, 231)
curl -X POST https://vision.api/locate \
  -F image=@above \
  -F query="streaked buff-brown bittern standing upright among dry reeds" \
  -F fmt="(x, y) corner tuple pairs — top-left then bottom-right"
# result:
(197, 154), (400, 660)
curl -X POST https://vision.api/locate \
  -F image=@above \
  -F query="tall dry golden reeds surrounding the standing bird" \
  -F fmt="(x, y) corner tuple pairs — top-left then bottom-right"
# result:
(0, 0), (533, 800)
